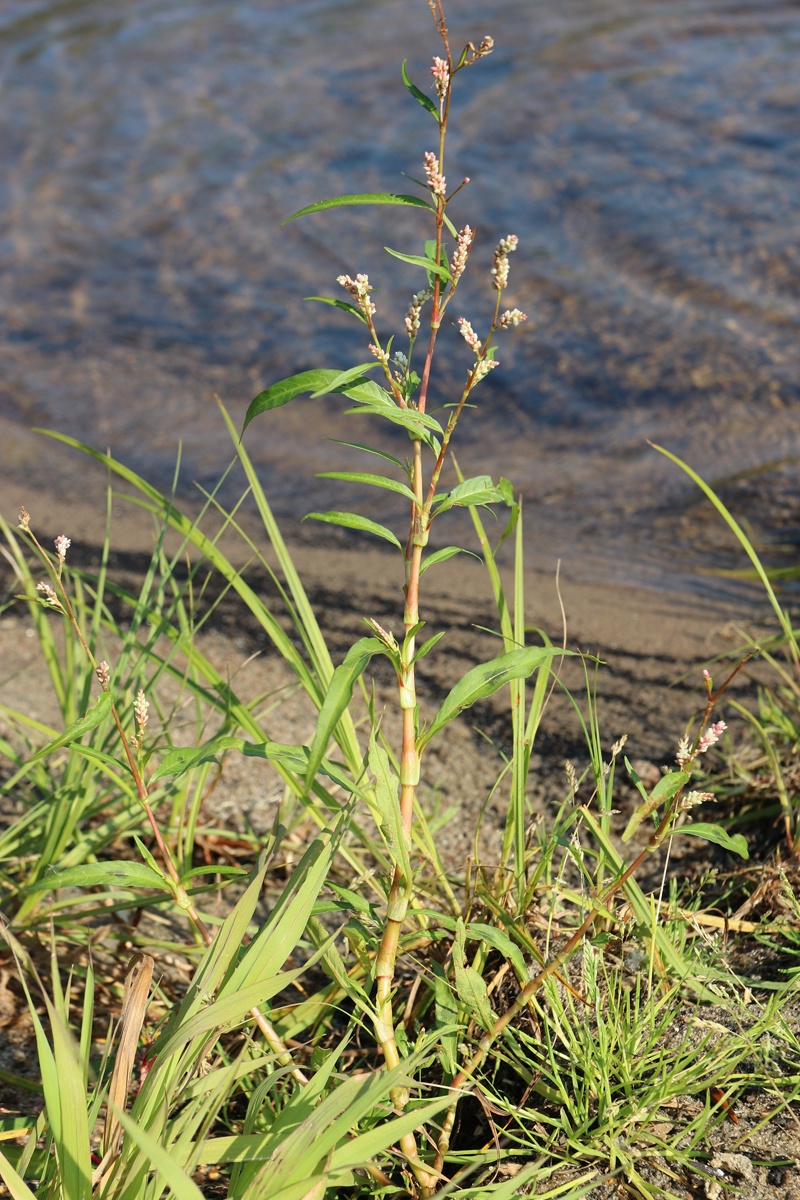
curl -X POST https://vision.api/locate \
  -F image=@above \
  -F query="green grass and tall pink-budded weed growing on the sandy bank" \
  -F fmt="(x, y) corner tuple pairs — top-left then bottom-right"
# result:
(0, 0), (800, 1200)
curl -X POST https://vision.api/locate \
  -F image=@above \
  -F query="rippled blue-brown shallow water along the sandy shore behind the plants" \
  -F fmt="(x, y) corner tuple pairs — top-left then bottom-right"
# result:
(0, 0), (800, 597)
